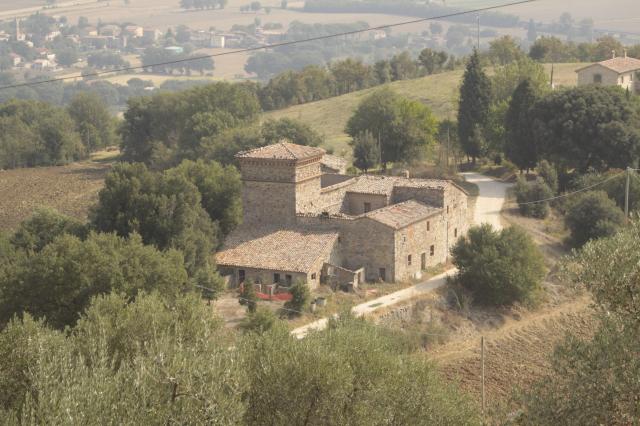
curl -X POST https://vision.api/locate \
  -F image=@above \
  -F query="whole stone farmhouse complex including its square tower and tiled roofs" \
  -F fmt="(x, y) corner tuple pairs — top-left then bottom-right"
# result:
(216, 142), (468, 288)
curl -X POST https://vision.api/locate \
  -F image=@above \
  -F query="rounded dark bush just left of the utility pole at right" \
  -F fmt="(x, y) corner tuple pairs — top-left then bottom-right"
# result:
(564, 191), (624, 247)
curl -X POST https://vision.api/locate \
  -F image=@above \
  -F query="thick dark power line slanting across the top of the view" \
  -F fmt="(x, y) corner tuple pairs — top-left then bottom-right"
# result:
(0, 0), (541, 90)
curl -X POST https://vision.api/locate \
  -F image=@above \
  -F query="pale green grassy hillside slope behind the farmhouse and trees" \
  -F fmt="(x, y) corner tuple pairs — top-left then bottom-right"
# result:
(264, 64), (581, 154)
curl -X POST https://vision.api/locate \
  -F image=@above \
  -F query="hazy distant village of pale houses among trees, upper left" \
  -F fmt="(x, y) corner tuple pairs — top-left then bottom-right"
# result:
(0, 15), (296, 72)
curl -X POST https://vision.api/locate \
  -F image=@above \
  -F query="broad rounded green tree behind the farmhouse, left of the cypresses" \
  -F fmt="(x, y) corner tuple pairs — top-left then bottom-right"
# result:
(346, 88), (437, 165)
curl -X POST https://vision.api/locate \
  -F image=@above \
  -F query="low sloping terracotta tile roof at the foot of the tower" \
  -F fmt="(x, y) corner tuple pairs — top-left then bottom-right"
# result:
(216, 226), (338, 273)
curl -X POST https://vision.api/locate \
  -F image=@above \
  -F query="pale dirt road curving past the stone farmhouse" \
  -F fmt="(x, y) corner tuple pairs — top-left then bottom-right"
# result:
(291, 173), (509, 339)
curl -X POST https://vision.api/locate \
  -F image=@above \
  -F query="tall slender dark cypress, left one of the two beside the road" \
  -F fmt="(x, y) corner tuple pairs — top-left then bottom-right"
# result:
(458, 51), (491, 163)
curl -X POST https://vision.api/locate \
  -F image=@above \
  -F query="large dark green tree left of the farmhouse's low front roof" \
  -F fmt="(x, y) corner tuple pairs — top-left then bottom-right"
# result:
(91, 164), (221, 282)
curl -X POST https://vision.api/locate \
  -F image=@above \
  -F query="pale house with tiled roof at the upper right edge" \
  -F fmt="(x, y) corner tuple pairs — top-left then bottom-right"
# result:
(576, 51), (640, 93)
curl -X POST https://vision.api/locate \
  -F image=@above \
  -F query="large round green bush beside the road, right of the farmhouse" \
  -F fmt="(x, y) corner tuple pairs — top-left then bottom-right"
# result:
(452, 224), (544, 306)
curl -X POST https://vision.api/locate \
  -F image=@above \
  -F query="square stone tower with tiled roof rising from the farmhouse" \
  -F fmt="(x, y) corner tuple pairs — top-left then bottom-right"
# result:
(236, 142), (325, 225)
